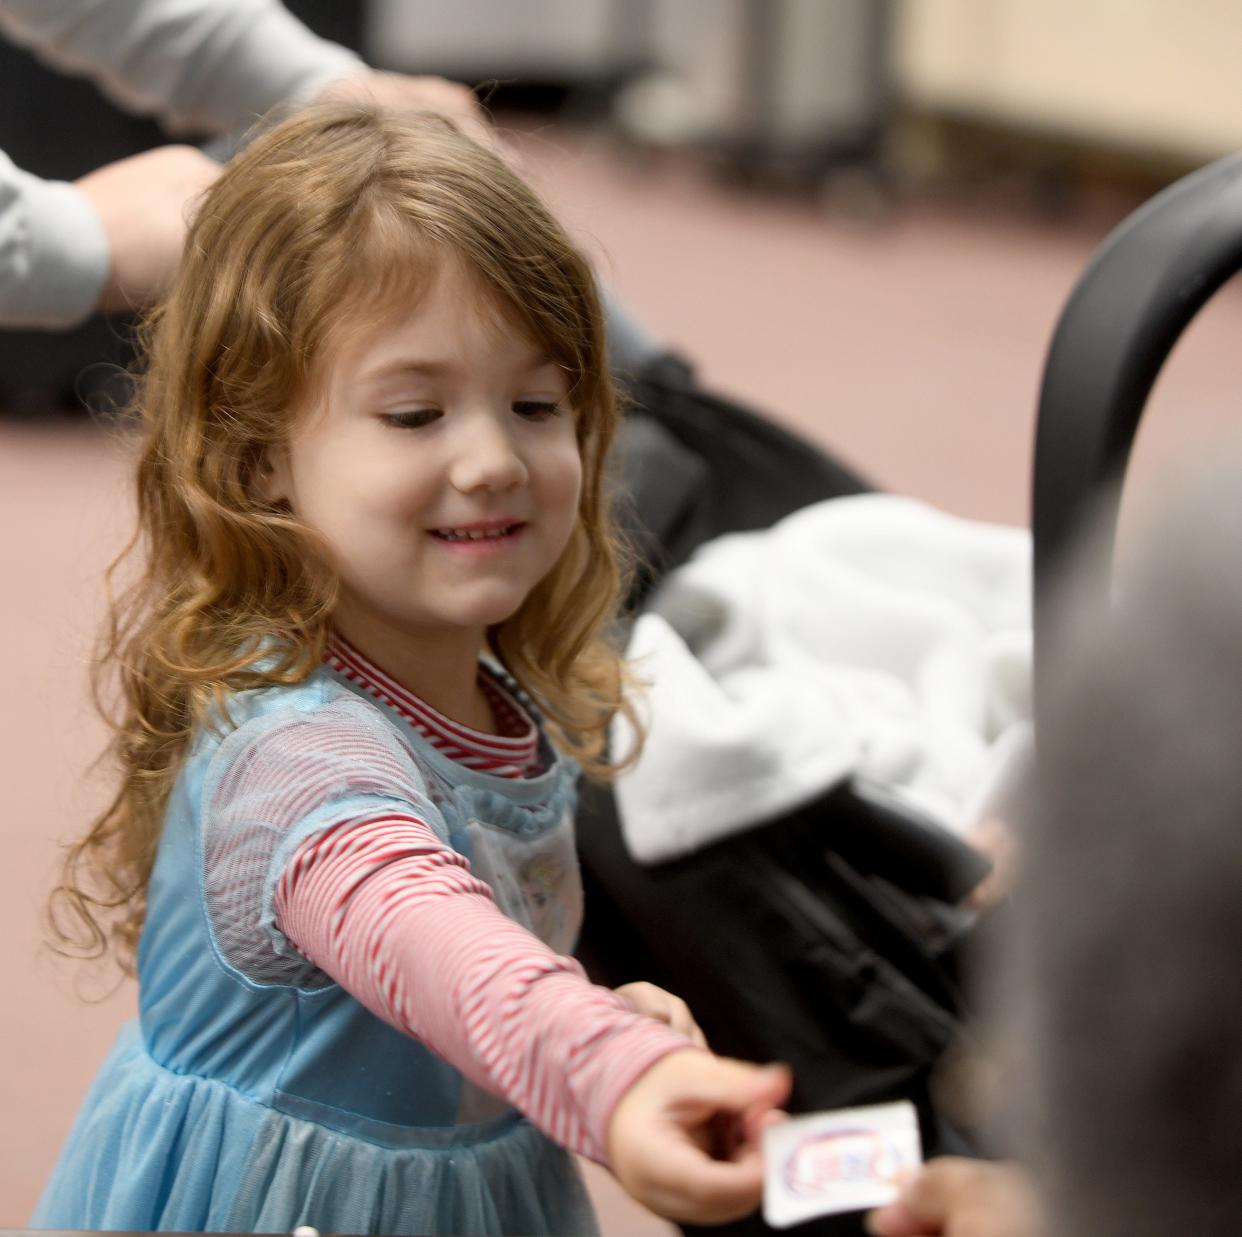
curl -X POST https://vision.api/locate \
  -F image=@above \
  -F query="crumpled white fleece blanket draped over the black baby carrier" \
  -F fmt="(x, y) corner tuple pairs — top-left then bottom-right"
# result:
(612, 494), (1031, 863)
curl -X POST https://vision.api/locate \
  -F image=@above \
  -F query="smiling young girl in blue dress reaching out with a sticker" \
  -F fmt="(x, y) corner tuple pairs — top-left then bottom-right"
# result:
(43, 107), (789, 1233)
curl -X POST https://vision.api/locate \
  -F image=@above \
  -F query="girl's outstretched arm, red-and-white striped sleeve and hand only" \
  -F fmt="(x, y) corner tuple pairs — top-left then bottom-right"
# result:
(277, 816), (790, 1223)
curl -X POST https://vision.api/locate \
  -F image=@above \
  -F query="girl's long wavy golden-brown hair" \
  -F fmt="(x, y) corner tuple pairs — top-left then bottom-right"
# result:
(51, 104), (626, 971)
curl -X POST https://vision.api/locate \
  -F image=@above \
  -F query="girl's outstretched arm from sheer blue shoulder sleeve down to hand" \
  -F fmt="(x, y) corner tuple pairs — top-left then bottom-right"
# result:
(213, 698), (787, 1220)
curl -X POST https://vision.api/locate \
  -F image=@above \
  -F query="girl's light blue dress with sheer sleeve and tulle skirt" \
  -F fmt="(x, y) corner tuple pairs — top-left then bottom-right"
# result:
(32, 667), (595, 1235)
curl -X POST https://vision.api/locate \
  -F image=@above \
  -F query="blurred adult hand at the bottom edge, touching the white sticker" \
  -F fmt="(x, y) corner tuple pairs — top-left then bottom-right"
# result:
(867, 1156), (1043, 1237)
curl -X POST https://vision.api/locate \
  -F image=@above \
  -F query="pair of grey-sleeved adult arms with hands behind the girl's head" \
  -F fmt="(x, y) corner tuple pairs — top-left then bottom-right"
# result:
(0, 0), (489, 329)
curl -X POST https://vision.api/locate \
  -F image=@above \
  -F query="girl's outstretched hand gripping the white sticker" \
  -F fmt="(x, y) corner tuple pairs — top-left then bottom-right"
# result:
(607, 1048), (791, 1225)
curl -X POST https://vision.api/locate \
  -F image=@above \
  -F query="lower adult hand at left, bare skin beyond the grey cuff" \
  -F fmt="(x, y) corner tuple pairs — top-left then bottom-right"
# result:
(76, 145), (220, 309)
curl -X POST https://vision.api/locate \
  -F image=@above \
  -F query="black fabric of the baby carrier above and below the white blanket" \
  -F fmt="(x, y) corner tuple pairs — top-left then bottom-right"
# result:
(578, 356), (986, 1237)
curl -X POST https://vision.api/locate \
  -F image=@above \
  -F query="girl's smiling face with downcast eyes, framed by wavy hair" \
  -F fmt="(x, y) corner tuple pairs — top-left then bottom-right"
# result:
(267, 262), (582, 659)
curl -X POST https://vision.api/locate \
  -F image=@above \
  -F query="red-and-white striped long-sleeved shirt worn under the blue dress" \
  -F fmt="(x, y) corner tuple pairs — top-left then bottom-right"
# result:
(276, 640), (689, 1162)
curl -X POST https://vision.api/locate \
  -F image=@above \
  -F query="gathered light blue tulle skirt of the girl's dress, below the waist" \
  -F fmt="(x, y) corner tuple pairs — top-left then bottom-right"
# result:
(31, 1025), (596, 1237)
